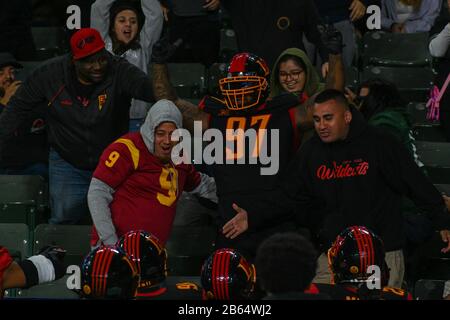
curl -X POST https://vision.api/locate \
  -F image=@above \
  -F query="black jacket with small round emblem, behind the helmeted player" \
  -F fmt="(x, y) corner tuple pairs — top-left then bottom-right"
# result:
(222, 0), (328, 66)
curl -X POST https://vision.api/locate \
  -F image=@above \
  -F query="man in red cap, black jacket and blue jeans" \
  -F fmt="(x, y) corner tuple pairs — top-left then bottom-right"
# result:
(0, 28), (159, 224)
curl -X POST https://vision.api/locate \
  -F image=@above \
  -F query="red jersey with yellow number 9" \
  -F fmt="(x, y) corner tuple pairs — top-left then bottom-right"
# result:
(92, 132), (201, 244)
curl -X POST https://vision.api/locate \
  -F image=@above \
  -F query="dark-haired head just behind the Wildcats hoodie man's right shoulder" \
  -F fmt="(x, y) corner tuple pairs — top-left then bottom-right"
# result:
(358, 78), (406, 120)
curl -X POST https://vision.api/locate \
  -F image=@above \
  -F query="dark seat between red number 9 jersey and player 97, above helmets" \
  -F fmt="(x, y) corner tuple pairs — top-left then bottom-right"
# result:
(166, 226), (216, 276)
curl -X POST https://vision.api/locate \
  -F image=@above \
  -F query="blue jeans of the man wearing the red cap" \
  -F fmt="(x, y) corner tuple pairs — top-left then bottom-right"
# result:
(49, 149), (93, 224)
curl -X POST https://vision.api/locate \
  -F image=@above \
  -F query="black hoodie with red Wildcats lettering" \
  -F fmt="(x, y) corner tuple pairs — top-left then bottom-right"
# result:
(278, 110), (450, 251)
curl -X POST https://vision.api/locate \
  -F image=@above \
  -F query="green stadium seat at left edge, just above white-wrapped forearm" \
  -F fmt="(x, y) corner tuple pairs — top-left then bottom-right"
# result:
(0, 223), (31, 261)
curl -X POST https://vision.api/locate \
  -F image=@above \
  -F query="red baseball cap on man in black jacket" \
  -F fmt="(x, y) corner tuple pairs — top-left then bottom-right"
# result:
(70, 28), (105, 60)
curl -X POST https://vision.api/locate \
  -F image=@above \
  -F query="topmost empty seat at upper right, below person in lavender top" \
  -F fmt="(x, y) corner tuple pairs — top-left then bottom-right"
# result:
(363, 31), (431, 67)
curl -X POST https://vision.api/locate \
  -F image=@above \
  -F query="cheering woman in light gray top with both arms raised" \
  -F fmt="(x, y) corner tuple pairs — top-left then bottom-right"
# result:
(91, 0), (163, 131)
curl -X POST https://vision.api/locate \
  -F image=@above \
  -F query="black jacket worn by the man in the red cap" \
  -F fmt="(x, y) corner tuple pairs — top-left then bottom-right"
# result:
(0, 54), (154, 170)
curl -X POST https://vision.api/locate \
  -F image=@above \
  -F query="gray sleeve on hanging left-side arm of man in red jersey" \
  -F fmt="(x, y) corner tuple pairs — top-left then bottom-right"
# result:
(88, 178), (117, 245)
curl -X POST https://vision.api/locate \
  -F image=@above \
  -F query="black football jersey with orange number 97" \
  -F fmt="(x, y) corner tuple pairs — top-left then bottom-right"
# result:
(199, 94), (301, 224)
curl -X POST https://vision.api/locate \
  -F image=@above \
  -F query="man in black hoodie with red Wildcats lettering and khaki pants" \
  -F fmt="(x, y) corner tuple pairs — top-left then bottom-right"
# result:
(237, 89), (450, 287)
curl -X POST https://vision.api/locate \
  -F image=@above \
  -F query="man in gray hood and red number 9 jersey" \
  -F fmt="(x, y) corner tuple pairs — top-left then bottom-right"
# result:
(88, 100), (217, 246)
